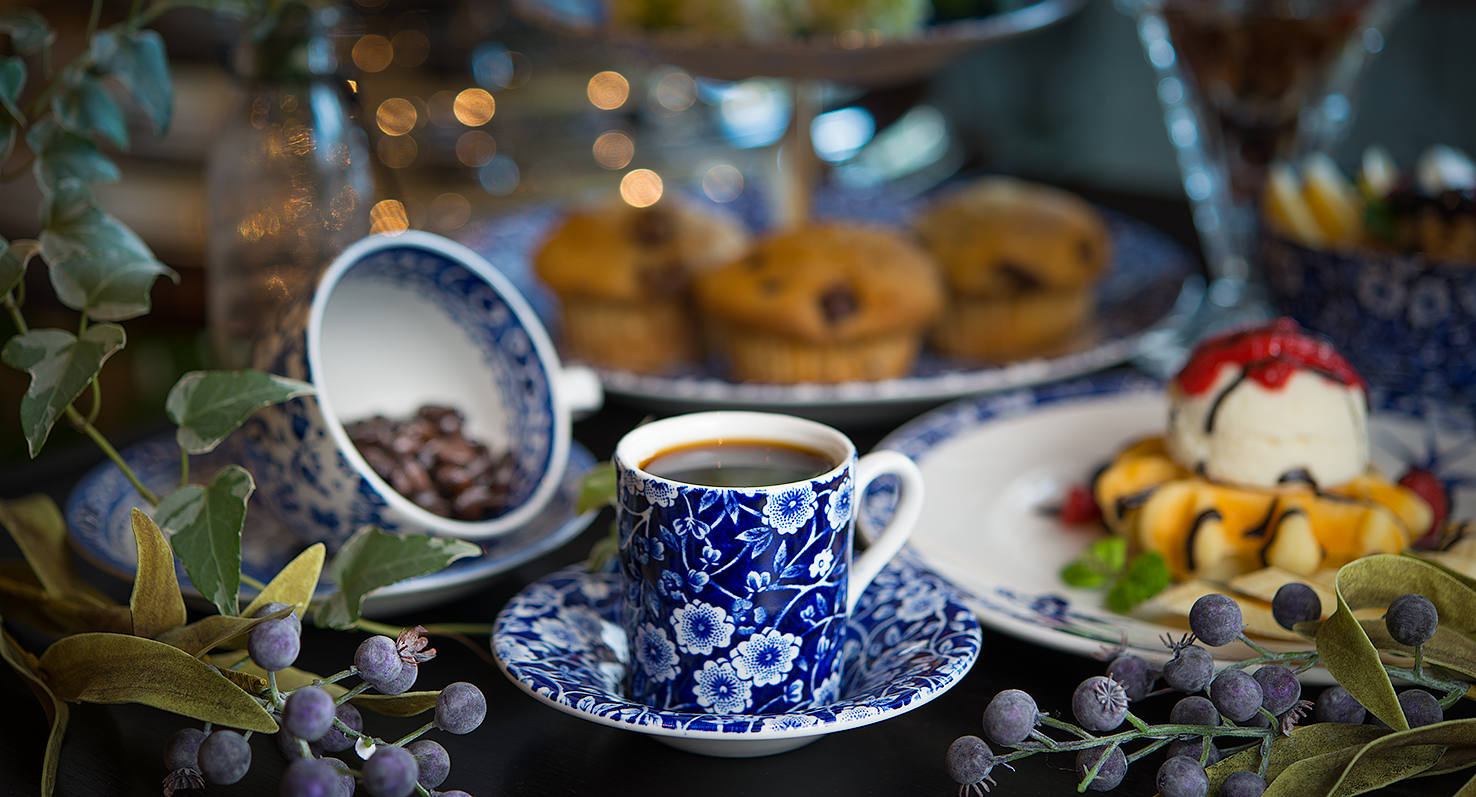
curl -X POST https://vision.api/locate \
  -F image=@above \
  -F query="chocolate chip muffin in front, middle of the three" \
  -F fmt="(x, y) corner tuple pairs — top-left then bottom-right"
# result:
(695, 224), (943, 382)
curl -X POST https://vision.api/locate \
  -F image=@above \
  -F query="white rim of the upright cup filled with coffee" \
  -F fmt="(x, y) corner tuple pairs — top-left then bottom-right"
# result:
(615, 410), (856, 491)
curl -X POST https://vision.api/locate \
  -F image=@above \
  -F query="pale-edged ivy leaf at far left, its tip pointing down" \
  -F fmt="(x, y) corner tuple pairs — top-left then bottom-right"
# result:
(0, 323), (124, 458)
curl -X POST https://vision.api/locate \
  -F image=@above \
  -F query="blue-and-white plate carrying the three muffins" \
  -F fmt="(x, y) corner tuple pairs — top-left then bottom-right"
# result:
(461, 189), (1201, 425)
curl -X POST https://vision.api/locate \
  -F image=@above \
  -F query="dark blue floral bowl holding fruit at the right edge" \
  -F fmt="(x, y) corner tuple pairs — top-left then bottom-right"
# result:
(1262, 235), (1476, 401)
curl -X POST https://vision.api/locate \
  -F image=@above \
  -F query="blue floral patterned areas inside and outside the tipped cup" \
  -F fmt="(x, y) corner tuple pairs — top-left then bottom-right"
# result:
(245, 246), (555, 551)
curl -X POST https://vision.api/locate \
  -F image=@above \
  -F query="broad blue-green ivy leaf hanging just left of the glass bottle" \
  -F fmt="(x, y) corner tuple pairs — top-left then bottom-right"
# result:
(41, 177), (179, 320)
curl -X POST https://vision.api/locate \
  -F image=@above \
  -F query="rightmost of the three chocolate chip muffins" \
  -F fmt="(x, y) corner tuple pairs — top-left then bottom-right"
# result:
(917, 177), (1111, 360)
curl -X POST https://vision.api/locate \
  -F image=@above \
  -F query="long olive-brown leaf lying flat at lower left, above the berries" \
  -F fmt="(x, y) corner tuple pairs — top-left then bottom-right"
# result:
(41, 633), (277, 734)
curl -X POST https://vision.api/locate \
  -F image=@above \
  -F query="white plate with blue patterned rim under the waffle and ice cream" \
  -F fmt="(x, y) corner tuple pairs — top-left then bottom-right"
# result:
(862, 372), (1476, 679)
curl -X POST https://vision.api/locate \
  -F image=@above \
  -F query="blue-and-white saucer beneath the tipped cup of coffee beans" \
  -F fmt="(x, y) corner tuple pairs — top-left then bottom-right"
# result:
(66, 434), (595, 617)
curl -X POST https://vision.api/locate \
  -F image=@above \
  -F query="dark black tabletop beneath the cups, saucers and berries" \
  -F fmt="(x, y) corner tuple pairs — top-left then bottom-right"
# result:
(0, 192), (1466, 797)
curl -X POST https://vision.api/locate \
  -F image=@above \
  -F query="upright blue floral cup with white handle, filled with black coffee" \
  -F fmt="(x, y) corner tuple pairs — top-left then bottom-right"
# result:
(614, 412), (923, 714)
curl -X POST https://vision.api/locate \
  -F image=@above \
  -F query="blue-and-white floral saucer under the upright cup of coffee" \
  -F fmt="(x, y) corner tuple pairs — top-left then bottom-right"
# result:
(492, 552), (980, 759)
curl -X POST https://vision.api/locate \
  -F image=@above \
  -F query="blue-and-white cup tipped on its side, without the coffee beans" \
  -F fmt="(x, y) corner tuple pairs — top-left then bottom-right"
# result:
(246, 232), (601, 549)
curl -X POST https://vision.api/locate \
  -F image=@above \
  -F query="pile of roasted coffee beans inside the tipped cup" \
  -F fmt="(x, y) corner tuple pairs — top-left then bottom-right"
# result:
(344, 404), (514, 521)
